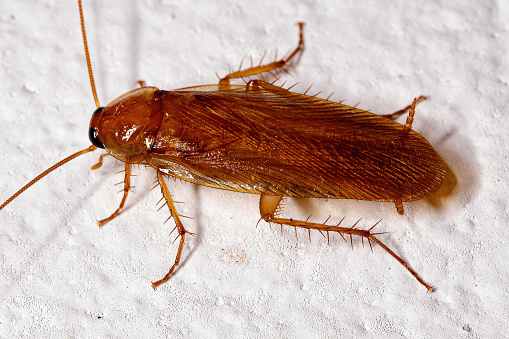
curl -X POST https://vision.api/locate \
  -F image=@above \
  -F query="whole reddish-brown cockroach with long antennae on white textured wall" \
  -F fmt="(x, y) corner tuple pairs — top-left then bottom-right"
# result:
(0, 0), (446, 291)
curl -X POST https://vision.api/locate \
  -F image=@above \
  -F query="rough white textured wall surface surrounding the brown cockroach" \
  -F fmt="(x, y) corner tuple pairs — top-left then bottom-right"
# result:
(0, 0), (509, 338)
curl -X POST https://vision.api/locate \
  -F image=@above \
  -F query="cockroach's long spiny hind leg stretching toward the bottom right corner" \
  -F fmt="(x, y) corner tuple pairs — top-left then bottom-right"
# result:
(260, 194), (434, 292)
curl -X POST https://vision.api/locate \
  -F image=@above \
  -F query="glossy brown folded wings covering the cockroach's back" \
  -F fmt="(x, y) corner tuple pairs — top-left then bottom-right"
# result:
(147, 83), (445, 201)
